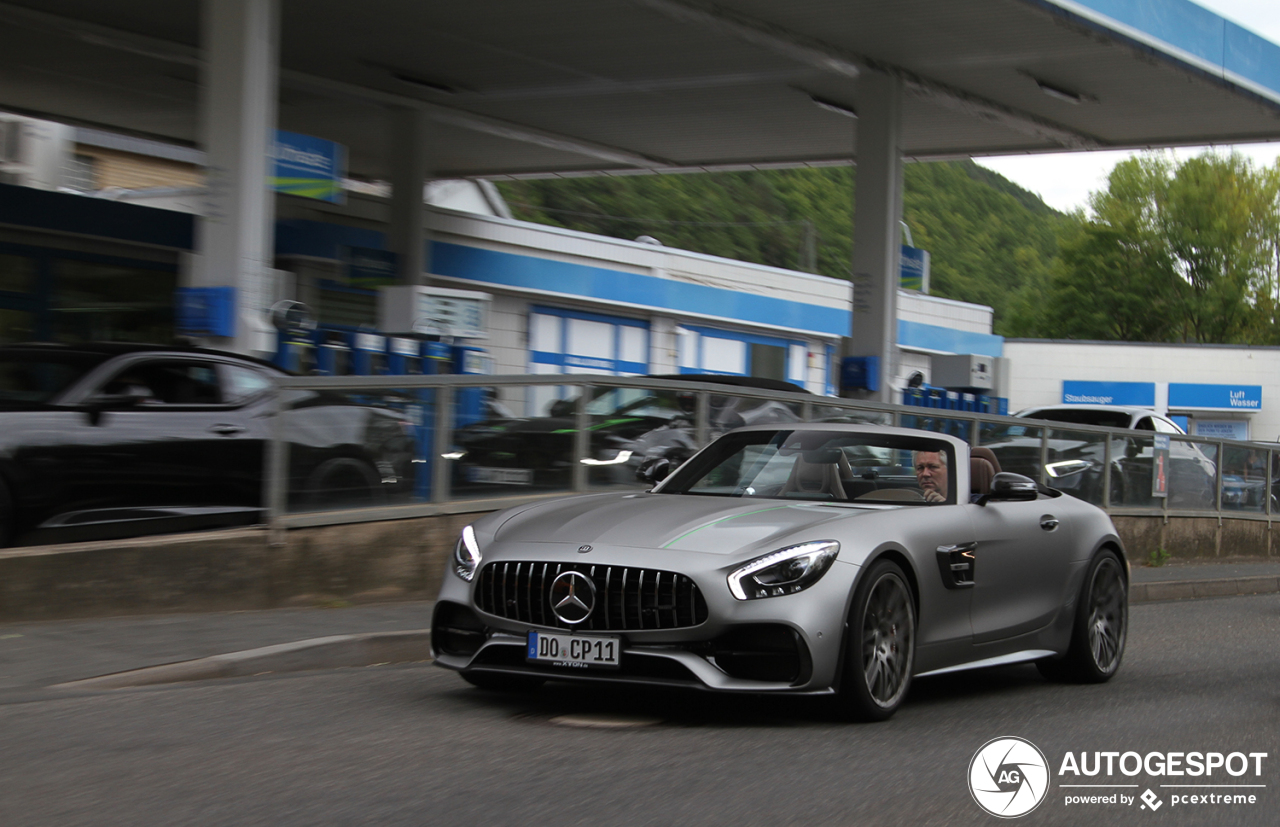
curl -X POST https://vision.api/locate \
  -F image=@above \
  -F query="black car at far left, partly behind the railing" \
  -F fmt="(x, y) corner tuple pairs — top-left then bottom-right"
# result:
(0, 344), (415, 544)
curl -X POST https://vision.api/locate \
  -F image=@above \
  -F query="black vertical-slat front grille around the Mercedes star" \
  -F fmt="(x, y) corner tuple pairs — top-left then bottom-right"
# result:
(475, 562), (707, 631)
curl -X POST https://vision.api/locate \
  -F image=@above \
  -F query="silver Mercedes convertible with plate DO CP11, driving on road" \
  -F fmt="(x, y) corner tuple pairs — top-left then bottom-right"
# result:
(431, 424), (1129, 719)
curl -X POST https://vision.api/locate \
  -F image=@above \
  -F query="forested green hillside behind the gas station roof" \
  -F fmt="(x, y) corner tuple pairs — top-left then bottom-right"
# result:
(499, 161), (1066, 333)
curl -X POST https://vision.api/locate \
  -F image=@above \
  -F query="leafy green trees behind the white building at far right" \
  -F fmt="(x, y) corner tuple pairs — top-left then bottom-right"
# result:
(1027, 152), (1280, 343)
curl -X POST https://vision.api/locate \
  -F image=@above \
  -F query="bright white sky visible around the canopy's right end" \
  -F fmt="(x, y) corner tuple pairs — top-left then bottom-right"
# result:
(974, 0), (1280, 213)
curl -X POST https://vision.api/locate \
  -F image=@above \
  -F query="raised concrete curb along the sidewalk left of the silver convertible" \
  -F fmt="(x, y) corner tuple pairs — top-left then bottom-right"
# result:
(51, 629), (431, 690)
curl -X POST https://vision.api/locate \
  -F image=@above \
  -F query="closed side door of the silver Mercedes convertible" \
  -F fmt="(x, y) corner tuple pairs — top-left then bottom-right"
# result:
(964, 497), (1073, 644)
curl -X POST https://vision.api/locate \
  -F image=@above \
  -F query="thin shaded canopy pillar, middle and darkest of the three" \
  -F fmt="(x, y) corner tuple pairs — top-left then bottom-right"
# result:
(387, 108), (431, 284)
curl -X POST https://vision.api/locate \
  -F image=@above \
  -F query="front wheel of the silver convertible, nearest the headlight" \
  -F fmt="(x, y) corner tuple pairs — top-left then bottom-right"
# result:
(840, 559), (915, 721)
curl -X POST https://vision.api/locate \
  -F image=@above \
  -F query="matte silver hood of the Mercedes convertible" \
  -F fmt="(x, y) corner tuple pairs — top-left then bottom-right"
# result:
(494, 494), (880, 554)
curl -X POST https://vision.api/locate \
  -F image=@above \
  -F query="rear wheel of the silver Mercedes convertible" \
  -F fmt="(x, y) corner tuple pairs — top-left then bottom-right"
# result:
(1036, 549), (1129, 684)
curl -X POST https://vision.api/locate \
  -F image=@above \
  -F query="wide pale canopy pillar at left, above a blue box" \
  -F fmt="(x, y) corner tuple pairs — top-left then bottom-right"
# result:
(188, 0), (280, 353)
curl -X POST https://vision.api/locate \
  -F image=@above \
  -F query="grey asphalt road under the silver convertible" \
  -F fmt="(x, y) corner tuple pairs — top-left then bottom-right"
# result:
(0, 595), (1280, 827)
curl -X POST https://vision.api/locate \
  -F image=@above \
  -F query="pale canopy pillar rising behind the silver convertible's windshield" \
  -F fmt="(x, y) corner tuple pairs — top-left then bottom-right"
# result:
(844, 72), (902, 402)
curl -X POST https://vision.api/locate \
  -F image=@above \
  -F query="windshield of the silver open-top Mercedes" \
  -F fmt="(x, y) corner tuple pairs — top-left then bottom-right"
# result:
(659, 430), (955, 504)
